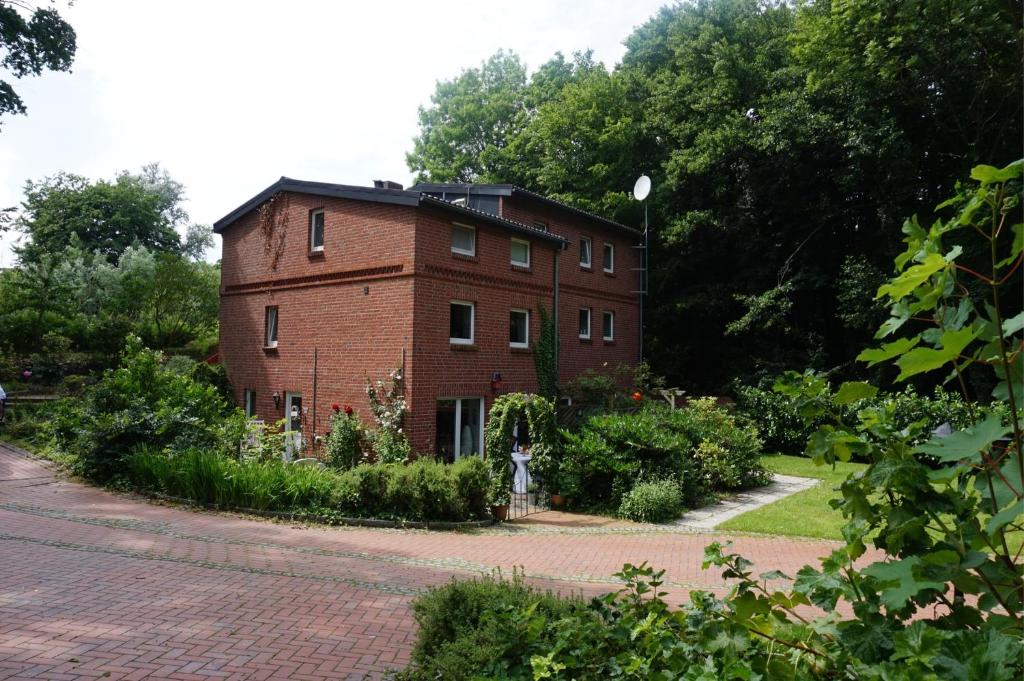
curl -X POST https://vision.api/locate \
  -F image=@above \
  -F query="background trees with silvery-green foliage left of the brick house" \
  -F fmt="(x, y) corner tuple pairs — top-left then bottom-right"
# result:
(0, 166), (220, 366)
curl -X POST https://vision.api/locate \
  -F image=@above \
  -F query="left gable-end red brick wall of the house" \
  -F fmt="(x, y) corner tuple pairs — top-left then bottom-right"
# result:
(220, 194), (416, 446)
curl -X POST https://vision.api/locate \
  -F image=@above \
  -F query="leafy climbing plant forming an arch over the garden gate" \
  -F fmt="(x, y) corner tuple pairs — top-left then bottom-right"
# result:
(483, 392), (558, 505)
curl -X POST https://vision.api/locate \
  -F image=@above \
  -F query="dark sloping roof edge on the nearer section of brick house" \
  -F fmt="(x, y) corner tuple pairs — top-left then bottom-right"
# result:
(213, 177), (567, 244)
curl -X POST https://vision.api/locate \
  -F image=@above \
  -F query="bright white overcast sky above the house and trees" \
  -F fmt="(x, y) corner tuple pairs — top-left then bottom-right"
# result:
(0, 0), (666, 266)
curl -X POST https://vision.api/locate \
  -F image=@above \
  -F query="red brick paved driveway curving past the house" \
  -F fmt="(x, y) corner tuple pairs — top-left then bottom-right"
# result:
(0, 444), (835, 679)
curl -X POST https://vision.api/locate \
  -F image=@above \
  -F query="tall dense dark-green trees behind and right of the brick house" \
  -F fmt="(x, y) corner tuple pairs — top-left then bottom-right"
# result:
(408, 0), (1024, 390)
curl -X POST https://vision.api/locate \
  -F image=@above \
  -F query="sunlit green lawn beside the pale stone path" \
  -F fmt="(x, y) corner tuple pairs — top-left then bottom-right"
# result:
(718, 455), (864, 540)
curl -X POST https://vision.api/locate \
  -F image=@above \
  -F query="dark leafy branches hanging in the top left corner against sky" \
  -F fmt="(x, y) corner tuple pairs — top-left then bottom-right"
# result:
(0, 2), (78, 125)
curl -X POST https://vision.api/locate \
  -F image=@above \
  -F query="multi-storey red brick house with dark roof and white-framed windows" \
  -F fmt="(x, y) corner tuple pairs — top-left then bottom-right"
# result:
(214, 177), (640, 457)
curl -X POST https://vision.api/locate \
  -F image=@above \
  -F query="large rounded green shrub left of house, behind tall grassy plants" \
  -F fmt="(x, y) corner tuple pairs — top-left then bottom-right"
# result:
(52, 338), (229, 482)
